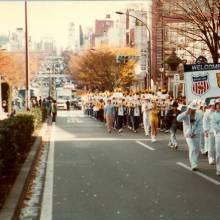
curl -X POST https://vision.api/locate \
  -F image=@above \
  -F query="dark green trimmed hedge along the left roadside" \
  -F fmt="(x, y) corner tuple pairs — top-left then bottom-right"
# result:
(0, 108), (45, 173)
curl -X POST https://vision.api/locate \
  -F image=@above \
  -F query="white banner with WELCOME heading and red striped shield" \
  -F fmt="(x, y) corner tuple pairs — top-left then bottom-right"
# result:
(184, 63), (220, 103)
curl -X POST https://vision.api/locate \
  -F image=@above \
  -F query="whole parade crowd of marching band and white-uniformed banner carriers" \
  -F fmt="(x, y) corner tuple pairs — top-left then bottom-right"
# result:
(82, 89), (220, 175)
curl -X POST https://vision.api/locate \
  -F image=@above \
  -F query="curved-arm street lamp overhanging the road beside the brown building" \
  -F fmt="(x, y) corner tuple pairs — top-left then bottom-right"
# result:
(115, 11), (151, 88)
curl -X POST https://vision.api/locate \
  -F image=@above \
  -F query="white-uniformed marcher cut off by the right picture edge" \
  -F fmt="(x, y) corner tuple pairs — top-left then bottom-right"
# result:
(211, 98), (220, 176)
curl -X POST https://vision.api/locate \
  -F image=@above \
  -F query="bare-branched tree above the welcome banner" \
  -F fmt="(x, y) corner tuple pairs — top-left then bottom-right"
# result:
(164, 0), (220, 63)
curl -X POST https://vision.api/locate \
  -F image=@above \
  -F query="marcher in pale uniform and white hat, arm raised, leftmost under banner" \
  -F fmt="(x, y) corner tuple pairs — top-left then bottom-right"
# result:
(177, 102), (202, 171)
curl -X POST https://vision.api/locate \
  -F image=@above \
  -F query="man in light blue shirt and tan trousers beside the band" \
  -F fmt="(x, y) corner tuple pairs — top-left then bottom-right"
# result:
(104, 99), (115, 133)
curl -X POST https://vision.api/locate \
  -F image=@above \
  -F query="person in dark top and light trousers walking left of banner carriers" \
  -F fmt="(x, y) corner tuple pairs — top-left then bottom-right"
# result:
(166, 102), (180, 149)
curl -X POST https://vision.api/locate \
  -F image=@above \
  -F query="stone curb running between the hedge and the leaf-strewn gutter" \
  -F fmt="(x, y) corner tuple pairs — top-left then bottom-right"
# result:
(0, 124), (46, 220)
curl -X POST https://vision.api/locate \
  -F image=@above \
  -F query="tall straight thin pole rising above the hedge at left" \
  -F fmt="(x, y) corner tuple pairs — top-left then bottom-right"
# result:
(24, 0), (29, 110)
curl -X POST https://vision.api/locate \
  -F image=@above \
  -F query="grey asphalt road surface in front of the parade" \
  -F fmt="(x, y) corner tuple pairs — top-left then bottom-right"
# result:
(41, 111), (220, 220)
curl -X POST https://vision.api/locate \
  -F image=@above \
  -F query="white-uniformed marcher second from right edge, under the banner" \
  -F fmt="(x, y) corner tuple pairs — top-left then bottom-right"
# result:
(203, 99), (215, 165)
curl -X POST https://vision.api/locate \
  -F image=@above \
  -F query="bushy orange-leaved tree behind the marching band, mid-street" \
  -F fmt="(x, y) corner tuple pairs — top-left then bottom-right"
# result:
(69, 48), (136, 91)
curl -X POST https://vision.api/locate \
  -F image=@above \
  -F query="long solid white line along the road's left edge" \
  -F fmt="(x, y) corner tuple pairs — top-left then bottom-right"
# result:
(40, 125), (55, 220)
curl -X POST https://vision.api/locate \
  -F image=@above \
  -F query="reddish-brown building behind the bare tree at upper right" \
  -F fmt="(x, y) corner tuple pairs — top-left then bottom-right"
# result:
(151, 0), (211, 93)
